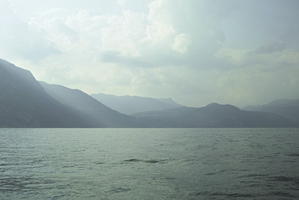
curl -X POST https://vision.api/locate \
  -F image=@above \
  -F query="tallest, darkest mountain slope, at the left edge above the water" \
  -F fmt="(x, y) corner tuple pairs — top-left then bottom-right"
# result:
(0, 59), (91, 128)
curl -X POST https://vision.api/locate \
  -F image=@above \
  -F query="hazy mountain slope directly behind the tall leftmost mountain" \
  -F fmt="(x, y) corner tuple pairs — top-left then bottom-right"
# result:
(40, 82), (137, 127)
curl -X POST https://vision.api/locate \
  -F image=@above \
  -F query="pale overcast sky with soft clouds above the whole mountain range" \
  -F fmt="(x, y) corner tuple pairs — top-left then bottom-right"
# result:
(0, 0), (299, 106)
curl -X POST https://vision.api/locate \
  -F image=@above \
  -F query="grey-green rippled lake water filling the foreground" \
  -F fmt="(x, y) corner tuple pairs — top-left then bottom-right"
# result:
(0, 129), (299, 200)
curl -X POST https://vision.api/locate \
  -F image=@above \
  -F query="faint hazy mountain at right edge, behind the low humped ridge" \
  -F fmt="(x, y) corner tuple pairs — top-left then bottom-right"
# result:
(244, 99), (299, 124)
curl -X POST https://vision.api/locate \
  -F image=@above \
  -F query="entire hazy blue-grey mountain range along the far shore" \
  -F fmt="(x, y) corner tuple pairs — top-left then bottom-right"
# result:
(0, 60), (299, 128)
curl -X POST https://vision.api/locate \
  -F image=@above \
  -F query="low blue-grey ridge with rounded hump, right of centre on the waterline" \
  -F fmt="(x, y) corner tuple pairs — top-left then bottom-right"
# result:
(134, 103), (298, 128)
